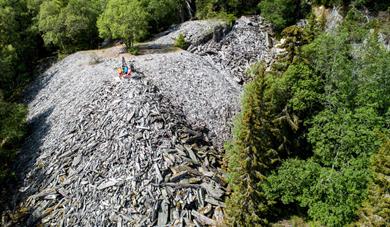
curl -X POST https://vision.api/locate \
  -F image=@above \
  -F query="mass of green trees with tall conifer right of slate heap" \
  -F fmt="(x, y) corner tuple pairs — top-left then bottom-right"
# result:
(227, 6), (390, 226)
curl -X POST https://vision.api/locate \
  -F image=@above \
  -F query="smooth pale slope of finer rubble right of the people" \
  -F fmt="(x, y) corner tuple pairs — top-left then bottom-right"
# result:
(134, 51), (241, 148)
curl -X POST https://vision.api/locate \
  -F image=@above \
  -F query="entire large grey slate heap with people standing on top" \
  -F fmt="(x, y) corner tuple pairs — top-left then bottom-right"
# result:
(3, 15), (274, 226)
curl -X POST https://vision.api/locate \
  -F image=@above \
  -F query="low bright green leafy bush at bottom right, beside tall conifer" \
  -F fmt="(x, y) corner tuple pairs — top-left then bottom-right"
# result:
(264, 159), (369, 226)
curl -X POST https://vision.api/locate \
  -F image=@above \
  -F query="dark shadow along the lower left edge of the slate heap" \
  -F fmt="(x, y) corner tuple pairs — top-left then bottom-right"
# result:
(0, 107), (54, 226)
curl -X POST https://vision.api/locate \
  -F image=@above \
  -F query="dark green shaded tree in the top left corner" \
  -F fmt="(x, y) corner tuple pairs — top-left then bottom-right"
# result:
(0, 0), (40, 96)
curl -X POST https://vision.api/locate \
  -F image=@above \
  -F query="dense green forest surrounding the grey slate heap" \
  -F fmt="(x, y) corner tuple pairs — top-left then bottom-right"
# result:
(0, 0), (390, 226)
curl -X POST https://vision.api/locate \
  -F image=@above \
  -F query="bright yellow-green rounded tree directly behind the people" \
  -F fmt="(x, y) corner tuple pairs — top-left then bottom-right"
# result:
(97, 0), (150, 48)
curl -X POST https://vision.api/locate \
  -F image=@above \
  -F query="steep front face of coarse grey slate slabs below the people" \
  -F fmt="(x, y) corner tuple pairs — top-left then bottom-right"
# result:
(3, 76), (226, 226)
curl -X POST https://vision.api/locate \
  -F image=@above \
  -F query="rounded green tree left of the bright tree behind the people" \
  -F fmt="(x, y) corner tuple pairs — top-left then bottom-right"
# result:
(37, 0), (100, 53)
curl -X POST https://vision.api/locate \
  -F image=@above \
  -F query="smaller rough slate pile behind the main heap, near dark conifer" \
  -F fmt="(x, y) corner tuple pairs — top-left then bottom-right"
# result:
(188, 16), (274, 84)
